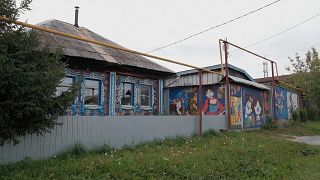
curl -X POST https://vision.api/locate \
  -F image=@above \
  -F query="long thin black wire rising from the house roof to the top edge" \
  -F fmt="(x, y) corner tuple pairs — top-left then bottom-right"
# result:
(148, 0), (280, 53)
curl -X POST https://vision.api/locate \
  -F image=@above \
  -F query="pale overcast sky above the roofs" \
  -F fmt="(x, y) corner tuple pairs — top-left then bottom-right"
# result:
(18, 0), (320, 77)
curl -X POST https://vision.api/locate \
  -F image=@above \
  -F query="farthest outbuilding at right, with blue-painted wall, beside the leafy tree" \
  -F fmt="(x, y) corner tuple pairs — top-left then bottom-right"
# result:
(255, 75), (302, 120)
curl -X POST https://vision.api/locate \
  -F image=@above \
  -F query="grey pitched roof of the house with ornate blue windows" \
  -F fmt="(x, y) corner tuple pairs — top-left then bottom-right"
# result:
(38, 20), (174, 73)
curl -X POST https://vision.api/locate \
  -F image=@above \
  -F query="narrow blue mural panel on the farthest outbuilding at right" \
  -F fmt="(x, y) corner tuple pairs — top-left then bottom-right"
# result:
(276, 87), (288, 120)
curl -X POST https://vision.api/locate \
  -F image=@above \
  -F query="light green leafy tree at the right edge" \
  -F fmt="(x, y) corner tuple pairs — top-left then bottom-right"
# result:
(289, 48), (320, 110)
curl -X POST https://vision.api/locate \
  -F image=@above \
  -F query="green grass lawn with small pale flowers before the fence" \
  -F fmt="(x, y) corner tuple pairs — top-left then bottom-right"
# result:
(0, 123), (320, 179)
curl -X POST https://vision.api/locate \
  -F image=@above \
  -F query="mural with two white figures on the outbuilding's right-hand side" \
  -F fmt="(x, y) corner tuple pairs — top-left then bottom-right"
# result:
(242, 87), (266, 128)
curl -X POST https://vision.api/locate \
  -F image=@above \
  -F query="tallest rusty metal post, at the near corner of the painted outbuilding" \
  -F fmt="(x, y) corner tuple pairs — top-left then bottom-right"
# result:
(223, 41), (231, 130)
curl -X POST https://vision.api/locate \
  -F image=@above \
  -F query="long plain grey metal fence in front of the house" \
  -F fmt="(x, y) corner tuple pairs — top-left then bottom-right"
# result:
(0, 115), (227, 164)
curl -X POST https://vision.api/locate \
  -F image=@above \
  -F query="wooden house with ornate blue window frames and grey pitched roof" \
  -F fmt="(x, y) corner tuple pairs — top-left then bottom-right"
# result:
(38, 20), (175, 116)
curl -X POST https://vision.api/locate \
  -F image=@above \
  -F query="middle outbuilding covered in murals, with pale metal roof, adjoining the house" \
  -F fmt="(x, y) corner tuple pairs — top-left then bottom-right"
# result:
(164, 65), (271, 129)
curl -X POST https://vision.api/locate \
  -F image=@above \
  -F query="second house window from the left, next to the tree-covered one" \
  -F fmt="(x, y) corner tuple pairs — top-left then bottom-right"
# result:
(84, 79), (100, 106)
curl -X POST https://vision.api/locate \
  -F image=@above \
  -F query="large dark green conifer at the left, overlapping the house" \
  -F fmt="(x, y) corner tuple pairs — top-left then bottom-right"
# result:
(0, 0), (75, 144)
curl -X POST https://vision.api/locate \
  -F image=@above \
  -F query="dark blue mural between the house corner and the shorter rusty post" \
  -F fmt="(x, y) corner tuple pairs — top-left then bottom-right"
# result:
(169, 87), (198, 115)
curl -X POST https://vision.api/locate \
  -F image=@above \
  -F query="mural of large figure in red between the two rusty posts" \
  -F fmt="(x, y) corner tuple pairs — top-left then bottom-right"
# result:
(202, 86), (225, 115)
